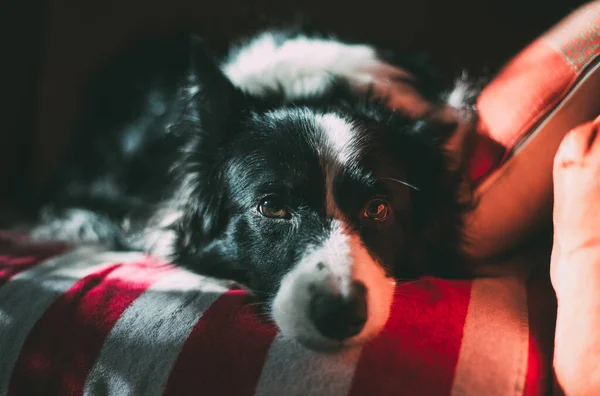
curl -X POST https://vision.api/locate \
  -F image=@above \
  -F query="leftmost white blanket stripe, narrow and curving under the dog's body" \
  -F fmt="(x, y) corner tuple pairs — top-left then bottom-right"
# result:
(0, 246), (143, 395)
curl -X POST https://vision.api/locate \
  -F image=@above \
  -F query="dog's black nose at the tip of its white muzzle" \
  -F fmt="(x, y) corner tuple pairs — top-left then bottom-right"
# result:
(310, 282), (367, 341)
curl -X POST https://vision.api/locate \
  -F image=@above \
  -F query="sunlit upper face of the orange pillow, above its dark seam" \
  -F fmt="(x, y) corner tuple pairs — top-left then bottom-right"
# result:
(478, 1), (600, 153)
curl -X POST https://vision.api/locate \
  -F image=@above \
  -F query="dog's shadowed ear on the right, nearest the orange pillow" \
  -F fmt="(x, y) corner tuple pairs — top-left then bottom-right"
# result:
(394, 108), (475, 276)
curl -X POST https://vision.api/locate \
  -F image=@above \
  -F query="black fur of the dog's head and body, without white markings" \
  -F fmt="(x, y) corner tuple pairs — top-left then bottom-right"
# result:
(32, 29), (476, 296)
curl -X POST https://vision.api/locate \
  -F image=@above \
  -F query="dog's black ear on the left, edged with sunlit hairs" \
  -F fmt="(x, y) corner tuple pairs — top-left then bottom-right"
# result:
(161, 36), (246, 255)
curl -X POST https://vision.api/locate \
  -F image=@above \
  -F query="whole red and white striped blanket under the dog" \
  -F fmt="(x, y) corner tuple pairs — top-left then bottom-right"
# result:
(0, 234), (552, 396)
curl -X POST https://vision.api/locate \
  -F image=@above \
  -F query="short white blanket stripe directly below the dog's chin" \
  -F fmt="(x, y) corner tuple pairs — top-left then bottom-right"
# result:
(255, 334), (361, 396)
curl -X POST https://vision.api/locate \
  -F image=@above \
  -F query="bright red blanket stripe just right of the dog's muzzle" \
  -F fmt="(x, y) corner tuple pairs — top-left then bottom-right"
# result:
(350, 278), (471, 396)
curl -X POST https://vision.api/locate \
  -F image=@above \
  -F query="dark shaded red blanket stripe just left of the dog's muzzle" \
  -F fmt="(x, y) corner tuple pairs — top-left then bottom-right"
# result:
(165, 290), (276, 396)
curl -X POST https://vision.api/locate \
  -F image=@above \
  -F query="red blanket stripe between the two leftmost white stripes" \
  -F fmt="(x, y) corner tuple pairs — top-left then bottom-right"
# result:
(9, 259), (171, 395)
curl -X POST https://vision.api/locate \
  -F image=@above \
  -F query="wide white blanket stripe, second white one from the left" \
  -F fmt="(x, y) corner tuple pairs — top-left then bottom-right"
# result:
(84, 270), (227, 396)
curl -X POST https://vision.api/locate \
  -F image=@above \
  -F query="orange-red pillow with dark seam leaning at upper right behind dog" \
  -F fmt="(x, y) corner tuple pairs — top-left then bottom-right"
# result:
(465, 1), (600, 259)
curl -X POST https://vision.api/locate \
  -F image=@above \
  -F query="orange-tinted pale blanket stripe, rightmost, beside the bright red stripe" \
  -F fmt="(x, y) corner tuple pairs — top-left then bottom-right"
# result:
(451, 276), (529, 396)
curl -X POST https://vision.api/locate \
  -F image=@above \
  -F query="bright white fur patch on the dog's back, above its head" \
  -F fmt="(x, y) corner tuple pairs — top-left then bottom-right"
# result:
(222, 32), (398, 99)
